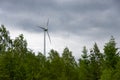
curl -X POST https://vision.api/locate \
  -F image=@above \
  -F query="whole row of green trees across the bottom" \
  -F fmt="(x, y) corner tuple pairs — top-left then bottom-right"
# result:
(0, 25), (120, 80)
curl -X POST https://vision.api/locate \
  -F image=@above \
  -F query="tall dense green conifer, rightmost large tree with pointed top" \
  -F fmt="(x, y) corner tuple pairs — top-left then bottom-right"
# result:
(100, 36), (119, 80)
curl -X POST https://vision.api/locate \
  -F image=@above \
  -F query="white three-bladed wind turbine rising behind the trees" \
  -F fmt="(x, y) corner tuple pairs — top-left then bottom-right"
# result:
(39, 19), (51, 57)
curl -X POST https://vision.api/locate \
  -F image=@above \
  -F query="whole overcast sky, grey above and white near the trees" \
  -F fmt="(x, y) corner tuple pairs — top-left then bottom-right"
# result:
(0, 0), (120, 58)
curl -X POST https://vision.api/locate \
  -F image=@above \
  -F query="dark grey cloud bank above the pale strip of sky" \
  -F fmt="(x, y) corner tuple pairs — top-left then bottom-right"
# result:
(0, 0), (120, 40)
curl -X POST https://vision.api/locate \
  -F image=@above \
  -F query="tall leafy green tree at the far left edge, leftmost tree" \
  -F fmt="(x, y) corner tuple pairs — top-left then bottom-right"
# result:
(0, 25), (14, 80)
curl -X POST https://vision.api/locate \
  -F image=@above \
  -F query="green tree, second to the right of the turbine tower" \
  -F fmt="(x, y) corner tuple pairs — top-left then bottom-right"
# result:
(62, 48), (78, 80)
